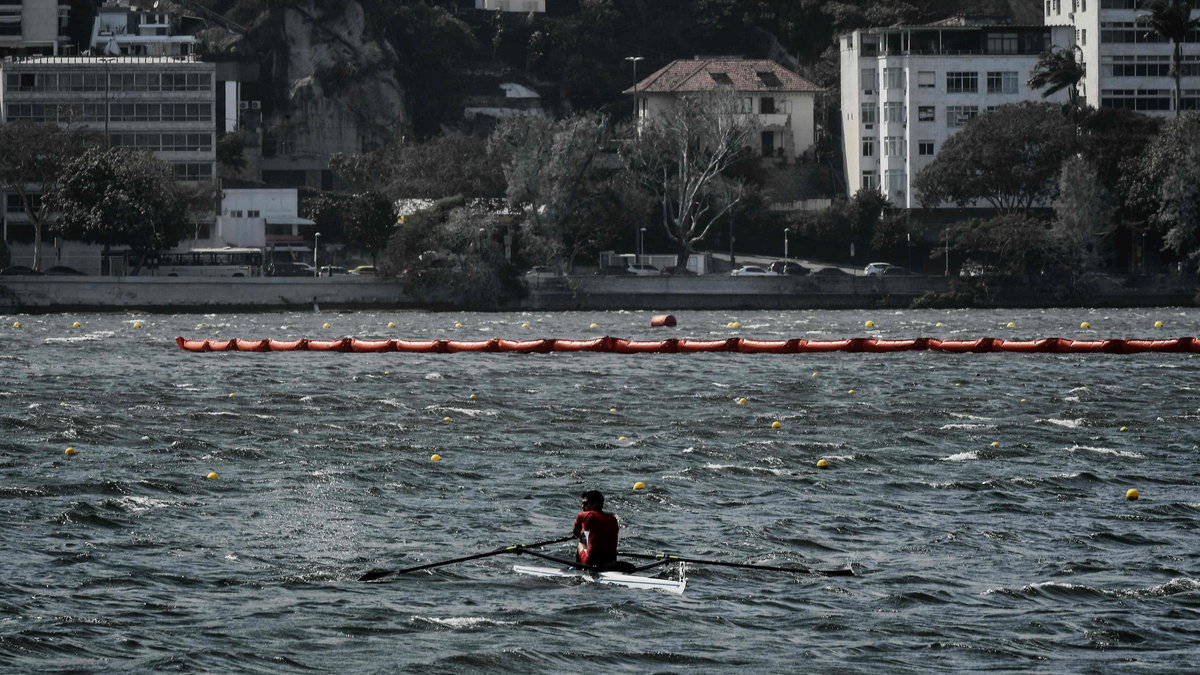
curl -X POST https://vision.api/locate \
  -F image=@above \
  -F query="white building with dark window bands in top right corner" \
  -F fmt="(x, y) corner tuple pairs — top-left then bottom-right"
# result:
(1044, 0), (1200, 117)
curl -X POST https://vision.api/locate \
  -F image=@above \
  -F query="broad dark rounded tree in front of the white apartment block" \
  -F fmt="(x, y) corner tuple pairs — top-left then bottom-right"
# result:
(913, 102), (1076, 214)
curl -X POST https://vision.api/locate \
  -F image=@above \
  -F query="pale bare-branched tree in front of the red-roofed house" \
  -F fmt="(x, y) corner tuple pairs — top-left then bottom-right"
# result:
(625, 91), (757, 267)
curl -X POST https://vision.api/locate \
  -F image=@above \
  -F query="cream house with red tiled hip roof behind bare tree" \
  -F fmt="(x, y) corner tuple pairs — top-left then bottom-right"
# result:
(624, 58), (821, 161)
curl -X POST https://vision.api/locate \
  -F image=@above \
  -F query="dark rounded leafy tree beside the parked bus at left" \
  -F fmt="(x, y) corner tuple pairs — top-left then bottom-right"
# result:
(46, 148), (194, 275)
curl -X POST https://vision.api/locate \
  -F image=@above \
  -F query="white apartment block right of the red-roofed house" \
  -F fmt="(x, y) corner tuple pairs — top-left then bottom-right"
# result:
(838, 18), (1074, 209)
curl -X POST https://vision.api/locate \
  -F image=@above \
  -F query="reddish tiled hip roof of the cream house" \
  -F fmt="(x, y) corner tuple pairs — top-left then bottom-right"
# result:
(624, 59), (822, 94)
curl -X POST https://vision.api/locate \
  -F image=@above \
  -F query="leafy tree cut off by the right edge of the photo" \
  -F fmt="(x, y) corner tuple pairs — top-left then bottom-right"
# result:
(1129, 110), (1200, 262)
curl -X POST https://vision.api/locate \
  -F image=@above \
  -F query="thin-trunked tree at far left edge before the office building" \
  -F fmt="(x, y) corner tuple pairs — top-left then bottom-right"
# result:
(0, 120), (101, 270)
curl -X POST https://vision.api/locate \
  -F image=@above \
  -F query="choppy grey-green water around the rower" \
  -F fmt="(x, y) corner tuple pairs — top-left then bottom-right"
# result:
(0, 309), (1200, 673)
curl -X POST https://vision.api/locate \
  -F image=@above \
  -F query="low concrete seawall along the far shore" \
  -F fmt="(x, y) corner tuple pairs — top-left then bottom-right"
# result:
(0, 275), (1196, 313)
